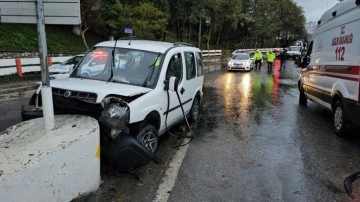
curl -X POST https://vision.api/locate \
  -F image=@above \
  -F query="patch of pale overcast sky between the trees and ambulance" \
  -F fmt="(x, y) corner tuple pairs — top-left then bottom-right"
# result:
(293, 0), (340, 22)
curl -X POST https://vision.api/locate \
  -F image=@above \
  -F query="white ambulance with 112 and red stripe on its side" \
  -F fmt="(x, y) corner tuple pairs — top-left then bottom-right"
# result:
(298, 0), (360, 135)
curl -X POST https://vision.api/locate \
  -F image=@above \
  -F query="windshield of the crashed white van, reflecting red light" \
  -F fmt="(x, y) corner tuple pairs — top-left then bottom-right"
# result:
(71, 47), (162, 88)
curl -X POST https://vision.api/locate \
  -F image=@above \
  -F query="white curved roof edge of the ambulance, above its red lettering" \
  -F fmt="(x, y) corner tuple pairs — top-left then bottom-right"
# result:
(318, 0), (358, 26)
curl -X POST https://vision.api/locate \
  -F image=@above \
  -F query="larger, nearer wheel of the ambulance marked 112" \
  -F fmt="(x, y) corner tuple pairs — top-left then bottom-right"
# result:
(333, 101), (348, 137)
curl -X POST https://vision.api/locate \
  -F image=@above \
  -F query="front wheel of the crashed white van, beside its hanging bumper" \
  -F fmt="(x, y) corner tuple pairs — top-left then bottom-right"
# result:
(135, 123), (159, 153)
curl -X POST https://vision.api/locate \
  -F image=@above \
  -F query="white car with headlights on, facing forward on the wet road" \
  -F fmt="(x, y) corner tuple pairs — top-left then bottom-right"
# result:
(228, 53), (254, 71)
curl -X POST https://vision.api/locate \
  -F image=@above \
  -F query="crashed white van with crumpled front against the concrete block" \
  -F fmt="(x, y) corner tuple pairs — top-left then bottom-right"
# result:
(22, 40), (204, 152)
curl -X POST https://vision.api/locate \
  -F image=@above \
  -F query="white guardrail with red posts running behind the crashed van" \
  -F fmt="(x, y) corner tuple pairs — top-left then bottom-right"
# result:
(0, 50), (222, 76)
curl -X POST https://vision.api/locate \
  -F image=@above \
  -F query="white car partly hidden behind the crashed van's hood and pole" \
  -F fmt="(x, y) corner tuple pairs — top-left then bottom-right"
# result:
(49, 54), (84, 79)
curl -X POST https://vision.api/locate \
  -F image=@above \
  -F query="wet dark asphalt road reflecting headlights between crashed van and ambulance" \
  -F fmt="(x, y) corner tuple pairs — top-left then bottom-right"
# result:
(0, 61), (360, 201)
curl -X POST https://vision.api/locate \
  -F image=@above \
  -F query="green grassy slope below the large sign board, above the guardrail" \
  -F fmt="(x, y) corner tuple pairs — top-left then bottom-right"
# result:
(0, 24), (106, 54)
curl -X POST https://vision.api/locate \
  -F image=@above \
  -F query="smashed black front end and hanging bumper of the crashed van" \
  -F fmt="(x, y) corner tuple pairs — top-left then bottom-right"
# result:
(21, 81), (160, 172)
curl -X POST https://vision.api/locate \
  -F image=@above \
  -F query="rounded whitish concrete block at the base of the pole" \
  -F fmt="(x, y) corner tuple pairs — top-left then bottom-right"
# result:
(0, 115), (100, 202)
